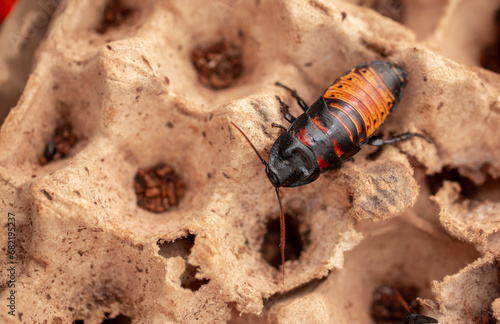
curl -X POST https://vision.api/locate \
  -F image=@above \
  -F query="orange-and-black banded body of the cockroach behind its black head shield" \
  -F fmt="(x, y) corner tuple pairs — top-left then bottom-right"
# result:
(289, 61), (407, 172)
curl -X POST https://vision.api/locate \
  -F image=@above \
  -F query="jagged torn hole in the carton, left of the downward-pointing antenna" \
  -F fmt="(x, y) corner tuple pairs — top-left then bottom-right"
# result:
(157, 234), (209, 291)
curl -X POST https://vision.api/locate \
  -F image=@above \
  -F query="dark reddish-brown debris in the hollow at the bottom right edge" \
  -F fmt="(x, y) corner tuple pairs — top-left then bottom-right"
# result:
(370, 285), (420, 324)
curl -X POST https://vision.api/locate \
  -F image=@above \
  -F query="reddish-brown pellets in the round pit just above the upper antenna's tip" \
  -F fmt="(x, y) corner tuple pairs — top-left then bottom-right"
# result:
(191, 40), (243, 90)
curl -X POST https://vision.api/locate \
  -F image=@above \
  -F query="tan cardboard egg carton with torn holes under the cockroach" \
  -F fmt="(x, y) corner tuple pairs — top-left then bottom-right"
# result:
(0, 0), (500, 323)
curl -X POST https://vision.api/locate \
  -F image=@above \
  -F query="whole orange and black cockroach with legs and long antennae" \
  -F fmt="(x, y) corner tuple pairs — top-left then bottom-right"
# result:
(232, 61), (432, 282)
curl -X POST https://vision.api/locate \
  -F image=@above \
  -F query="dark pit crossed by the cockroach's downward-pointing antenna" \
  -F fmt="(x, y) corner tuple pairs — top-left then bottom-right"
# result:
(261, 214), (309, 269)
